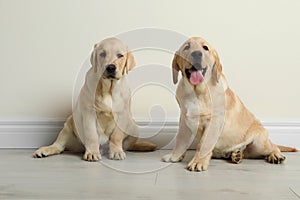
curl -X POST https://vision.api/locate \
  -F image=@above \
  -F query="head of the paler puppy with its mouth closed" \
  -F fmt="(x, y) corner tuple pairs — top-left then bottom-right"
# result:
(91, 38), (135, 80)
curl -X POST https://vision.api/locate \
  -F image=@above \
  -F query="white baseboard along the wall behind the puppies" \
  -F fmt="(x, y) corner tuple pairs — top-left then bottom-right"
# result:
(0, 119), (300, 149)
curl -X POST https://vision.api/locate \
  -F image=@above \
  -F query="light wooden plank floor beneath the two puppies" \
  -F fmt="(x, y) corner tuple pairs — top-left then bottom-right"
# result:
(0, 149), (300, 200)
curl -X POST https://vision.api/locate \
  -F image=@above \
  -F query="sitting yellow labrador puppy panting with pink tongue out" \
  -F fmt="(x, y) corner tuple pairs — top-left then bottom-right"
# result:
(162, 37), (296, 171)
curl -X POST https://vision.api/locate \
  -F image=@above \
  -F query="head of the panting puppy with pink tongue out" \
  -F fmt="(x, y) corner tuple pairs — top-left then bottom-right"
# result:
(172, 37), (222, 85)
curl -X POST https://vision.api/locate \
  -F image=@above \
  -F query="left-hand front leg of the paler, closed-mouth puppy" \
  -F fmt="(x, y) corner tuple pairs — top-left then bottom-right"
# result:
(79, 114), (101, 161)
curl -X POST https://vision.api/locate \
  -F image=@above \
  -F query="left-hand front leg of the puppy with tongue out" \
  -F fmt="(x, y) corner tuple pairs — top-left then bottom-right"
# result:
(162, 114), (197, 162)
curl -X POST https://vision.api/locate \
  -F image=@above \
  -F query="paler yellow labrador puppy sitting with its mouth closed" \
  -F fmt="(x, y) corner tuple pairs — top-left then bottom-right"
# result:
(33, 38), (156, 161)
